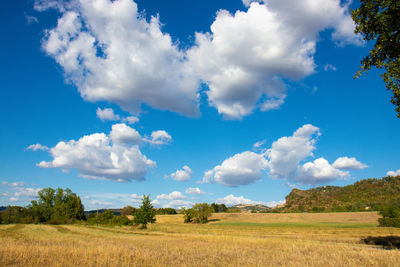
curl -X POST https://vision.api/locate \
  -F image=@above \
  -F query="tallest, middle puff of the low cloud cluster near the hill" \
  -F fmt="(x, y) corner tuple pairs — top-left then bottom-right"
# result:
(267, 124), (320, 178)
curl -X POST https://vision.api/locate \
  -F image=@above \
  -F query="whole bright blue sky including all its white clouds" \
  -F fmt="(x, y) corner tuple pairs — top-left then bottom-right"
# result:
(0, 0), (400, 209)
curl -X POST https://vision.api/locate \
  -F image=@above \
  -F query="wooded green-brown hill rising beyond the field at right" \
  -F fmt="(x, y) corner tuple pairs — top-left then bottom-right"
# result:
(274, 176), (400, 212)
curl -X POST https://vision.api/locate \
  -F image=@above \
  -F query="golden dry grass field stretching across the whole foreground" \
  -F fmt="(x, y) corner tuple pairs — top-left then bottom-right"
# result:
(0, 212), (400, 266)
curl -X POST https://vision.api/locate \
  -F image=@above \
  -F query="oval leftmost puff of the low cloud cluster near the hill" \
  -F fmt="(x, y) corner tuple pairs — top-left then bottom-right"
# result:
(203, 151), (267, 187)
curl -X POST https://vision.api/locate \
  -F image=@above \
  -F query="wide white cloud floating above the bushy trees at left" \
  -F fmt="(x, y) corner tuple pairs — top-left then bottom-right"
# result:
(38, 124), (156, 182)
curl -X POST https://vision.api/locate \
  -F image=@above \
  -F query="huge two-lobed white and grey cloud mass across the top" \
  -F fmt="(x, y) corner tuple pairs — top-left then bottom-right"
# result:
(35, 0), (361, 119)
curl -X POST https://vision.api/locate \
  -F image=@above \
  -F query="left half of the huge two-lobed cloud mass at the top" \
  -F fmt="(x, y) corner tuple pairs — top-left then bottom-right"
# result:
(43, 0), (199, 116)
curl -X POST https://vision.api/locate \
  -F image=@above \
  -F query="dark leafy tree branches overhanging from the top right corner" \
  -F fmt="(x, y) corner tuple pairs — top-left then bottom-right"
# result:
(352, 0), (400, 118)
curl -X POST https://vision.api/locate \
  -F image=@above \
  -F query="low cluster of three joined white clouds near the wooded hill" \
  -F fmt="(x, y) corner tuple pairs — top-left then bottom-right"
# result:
(202, 124), (368, 187)
